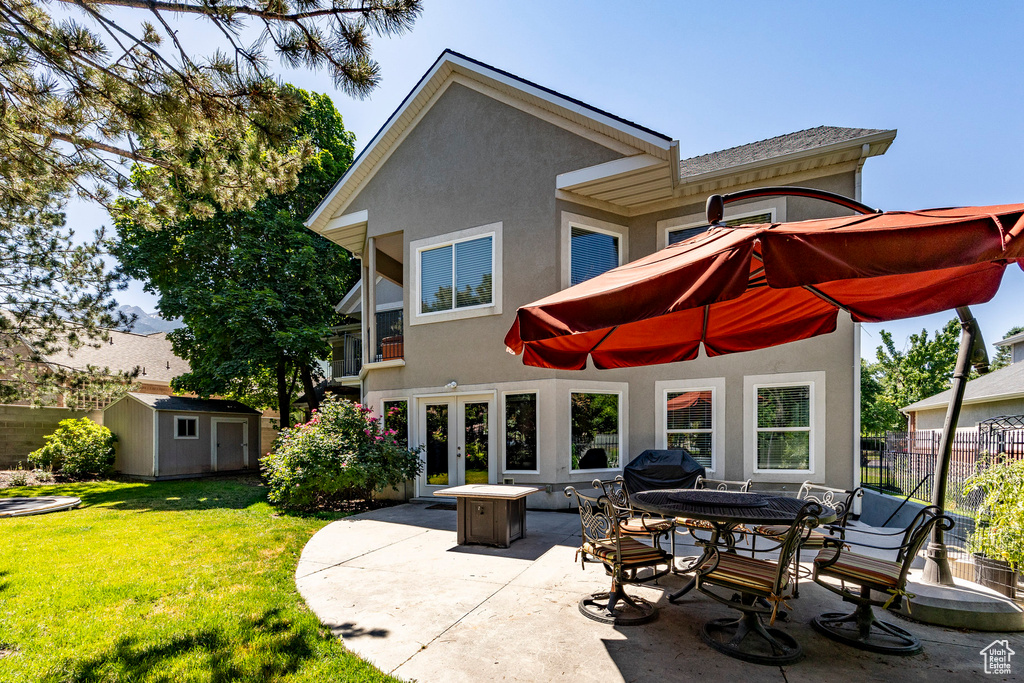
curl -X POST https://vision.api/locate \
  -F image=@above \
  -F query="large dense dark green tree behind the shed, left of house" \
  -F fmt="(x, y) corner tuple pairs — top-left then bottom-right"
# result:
(116, 88), (356, 424)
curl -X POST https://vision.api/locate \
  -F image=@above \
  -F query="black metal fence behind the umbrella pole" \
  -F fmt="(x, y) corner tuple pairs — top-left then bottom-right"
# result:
(860, 428), (1024, 594)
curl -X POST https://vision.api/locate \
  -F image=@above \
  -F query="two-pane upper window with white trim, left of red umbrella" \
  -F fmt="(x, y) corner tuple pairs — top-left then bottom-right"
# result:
(409, 223), (502, 325)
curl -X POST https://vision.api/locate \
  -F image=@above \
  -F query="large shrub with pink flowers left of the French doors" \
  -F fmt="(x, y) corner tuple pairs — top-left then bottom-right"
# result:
(260, 396), (421, 510)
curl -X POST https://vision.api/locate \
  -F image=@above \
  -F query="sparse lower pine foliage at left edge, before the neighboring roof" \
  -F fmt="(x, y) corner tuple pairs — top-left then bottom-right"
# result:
(0, 185), (132, 408)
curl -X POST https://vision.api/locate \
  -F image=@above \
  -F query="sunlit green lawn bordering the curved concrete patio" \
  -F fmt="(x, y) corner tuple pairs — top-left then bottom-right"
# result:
(0, 479), (395, 683)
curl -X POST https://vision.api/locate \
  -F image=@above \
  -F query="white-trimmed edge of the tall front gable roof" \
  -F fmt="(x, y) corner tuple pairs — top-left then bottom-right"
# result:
(305, 50), (676, 245)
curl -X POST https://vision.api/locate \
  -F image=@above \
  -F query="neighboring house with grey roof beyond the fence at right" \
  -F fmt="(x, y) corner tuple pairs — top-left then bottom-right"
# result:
(901, 333), (1024, 431)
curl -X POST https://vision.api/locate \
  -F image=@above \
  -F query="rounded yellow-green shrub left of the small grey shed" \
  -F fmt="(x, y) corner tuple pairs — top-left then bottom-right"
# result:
(29, 418), (118, 479)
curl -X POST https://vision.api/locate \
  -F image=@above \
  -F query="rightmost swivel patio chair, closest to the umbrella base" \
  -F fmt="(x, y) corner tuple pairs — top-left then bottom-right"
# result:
(811, 505), (953, 654)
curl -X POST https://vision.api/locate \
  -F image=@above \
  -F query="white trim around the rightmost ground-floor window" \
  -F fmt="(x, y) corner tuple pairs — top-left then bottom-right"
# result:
(743, 372), (825, 483)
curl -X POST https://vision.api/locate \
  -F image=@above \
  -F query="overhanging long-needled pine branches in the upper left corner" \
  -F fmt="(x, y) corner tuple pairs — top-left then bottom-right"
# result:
(0, 0), (421, 226)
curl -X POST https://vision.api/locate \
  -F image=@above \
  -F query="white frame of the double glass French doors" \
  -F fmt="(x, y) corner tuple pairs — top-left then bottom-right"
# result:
(416, 391), (498, 496)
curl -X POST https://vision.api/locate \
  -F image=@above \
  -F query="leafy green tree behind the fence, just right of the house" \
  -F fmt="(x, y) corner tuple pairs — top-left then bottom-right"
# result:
(861, 318), (961, 431)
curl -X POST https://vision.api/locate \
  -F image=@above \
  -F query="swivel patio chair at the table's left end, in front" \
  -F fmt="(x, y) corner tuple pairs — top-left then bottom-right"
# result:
(565, 486), (672, 626)
